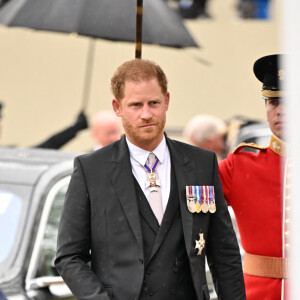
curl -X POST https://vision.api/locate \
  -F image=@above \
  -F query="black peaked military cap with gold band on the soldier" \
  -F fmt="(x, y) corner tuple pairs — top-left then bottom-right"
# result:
(253, 54), (285, 99)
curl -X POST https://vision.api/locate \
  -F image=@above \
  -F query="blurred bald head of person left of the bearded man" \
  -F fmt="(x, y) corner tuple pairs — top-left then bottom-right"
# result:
(91, 110), (122, 150)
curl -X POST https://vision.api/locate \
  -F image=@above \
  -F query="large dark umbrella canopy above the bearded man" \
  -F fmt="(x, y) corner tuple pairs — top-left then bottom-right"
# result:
(0, 0), (198, 48)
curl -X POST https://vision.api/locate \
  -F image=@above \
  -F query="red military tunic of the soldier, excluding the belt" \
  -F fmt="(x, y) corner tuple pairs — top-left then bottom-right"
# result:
(219, 136), (285, 300)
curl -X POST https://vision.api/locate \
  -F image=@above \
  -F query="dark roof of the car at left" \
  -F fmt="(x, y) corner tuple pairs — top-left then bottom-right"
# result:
(0, 148), (78, 185)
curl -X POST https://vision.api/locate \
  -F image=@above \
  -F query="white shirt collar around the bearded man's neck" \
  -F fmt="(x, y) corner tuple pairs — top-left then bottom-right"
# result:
(126, 136), (167, 166)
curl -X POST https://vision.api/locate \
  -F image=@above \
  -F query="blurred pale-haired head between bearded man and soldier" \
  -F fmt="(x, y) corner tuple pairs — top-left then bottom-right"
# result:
(184, 115), (226, 160)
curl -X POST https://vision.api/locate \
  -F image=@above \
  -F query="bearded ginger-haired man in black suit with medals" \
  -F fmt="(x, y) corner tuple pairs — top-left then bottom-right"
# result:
(55, 59), (245, 300)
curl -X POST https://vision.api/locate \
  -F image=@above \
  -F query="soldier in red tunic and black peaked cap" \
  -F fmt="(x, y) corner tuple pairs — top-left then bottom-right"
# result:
(219, 55), (289, 300)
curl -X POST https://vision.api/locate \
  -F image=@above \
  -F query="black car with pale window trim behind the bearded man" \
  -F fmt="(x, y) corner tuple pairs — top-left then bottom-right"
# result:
(0, 148), (75, 300)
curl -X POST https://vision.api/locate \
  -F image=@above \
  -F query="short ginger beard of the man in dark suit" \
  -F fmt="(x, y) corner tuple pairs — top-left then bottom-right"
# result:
(122, 118), (166, 148)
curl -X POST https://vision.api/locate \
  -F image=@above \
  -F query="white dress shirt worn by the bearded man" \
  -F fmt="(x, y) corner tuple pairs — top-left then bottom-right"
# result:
(126, 137), (171, 212)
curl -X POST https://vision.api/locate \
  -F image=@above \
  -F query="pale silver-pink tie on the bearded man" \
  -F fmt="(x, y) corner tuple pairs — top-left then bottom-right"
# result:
(148, 152), (163, 225)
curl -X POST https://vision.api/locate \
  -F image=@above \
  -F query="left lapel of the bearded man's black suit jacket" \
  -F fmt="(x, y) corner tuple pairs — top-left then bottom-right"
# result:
(108, 136), (143, 247)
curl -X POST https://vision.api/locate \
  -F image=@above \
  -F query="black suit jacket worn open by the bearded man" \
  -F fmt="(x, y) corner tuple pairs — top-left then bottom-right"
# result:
(55, 137), (245, 300)
